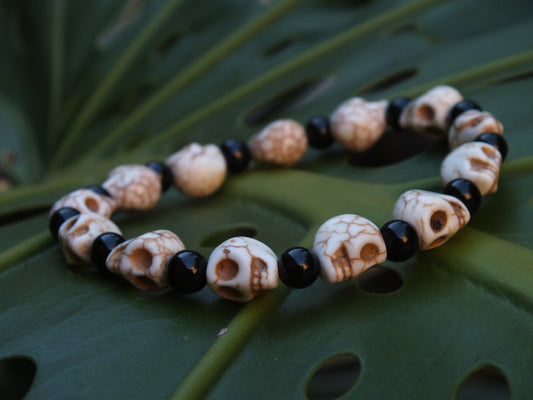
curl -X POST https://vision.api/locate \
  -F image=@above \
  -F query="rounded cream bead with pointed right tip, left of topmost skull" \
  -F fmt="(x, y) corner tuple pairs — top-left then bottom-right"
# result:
(331, 97), (389, 151)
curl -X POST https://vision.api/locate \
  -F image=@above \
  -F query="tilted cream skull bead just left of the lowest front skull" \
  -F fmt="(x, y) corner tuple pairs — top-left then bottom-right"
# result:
(106, 230), (185, 290)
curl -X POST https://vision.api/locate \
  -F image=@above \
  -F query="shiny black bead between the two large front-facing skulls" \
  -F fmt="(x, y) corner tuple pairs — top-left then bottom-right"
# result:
(278, 247), (320, 289)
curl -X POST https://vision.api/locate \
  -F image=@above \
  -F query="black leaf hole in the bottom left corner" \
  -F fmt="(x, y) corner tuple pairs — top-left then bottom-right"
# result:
(0, 356), (37, 400)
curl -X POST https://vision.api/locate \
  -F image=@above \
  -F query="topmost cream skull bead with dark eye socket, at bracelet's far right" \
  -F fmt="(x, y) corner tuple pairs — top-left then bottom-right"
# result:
(400, 85), (463, 136)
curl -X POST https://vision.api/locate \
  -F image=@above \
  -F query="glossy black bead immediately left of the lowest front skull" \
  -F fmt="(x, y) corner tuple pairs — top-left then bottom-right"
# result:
(167, 250), (207, 294)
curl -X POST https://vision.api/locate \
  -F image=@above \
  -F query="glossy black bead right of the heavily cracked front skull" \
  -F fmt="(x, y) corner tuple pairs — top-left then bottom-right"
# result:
(381, 219), (419, 261)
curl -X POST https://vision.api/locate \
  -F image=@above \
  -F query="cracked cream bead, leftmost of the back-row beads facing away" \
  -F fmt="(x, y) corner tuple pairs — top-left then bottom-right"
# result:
(102, 164), (161, 210)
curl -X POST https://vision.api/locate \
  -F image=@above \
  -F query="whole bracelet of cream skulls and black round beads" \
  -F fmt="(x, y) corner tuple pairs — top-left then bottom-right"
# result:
(49, 86), (507, 301)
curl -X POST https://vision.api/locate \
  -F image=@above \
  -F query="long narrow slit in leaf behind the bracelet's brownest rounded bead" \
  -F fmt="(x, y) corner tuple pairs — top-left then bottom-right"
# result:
(243, 76), (336, 126)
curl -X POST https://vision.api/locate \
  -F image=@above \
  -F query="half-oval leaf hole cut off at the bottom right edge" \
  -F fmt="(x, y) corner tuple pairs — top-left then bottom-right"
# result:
(455, 365), (511, 400)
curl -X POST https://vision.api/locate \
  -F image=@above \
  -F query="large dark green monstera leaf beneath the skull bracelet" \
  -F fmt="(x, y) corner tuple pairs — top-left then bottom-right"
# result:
(0, 0), (533, 399)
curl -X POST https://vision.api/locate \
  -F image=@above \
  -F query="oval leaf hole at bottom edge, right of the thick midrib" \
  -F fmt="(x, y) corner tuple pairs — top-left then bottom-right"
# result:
(305, 353), (361, 400)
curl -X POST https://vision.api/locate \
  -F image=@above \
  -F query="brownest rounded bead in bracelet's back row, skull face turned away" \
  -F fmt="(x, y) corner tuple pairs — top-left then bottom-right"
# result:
(249, 119), (307, 167)
